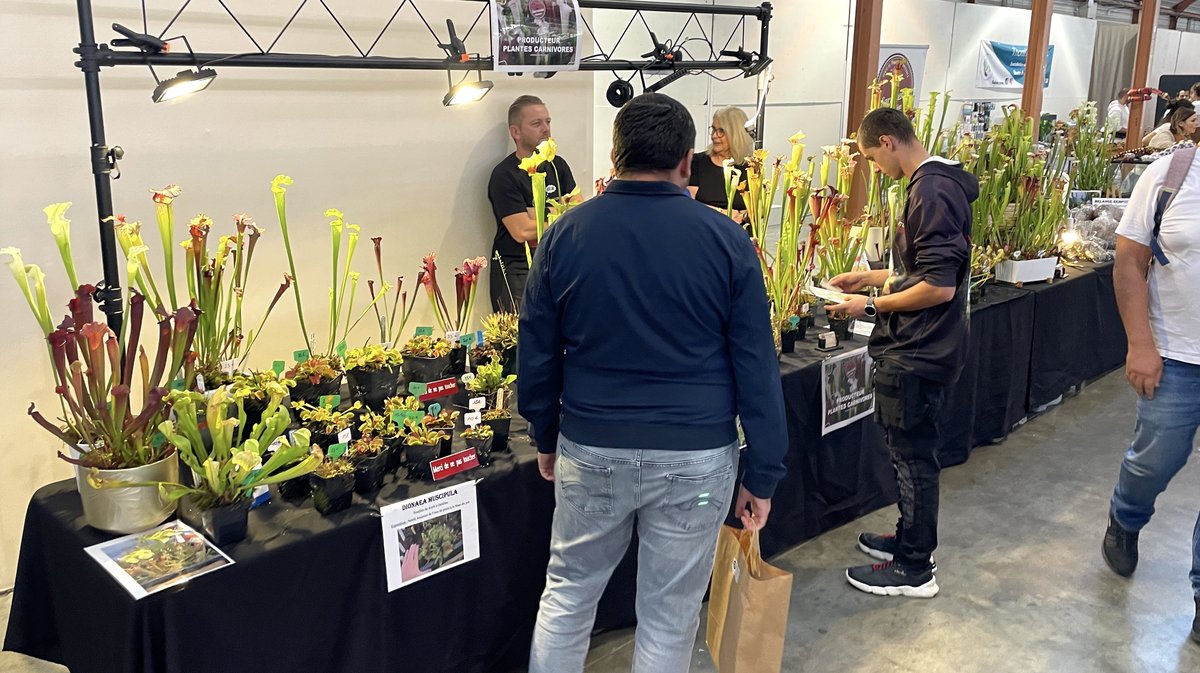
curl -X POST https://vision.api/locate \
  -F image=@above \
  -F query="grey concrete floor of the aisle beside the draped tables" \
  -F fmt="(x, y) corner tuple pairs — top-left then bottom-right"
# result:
(0, 373), (1200, 673)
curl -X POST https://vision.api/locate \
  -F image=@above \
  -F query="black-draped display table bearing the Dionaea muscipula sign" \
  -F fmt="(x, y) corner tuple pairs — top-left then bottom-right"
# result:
(5, 345), (895, 673)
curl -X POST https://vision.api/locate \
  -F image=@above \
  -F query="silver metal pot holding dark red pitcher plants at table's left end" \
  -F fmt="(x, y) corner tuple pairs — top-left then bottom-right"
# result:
(76, 452), (179, 535)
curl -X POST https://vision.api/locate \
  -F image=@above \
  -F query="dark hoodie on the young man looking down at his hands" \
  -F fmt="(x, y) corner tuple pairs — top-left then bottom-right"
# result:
(870, 158), (979, 384)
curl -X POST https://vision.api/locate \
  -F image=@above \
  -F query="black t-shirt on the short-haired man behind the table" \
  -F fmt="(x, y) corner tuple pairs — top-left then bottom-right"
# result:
(487, 152), (575, 266)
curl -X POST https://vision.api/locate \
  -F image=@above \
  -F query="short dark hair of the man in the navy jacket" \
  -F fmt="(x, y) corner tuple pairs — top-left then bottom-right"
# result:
(612, 94), (696, 174)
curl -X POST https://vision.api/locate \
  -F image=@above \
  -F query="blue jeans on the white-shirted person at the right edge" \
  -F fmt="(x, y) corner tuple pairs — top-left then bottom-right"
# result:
(1112, 360), (1200, 596)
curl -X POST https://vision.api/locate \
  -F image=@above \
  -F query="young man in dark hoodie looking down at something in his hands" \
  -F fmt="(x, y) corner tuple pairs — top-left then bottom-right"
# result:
(828, 108), (979, 599)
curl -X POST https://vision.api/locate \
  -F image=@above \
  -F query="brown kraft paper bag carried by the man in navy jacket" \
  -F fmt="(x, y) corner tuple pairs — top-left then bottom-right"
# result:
(706, 525), (792, 673)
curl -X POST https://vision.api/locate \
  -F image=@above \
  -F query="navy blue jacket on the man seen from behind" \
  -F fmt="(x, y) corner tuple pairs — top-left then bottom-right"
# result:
(517, 180), (787, 498)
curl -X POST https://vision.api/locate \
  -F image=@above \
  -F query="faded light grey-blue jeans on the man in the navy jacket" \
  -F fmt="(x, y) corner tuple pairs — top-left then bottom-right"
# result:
(529, 435), (738, 673)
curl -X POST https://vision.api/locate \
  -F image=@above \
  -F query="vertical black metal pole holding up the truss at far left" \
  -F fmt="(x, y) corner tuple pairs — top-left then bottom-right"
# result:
(76, 0), (124, 334)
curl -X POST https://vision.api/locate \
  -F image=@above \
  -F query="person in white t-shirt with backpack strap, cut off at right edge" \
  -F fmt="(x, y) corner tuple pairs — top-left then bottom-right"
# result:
(1102, 148), (1200, 643)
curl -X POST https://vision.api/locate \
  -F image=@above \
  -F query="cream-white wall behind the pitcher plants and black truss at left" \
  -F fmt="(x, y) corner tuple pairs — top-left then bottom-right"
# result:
(0, 0), (593, 587)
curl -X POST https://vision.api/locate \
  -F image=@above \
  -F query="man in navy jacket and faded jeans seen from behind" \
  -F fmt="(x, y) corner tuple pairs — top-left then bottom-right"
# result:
(517, 94), (787, 673)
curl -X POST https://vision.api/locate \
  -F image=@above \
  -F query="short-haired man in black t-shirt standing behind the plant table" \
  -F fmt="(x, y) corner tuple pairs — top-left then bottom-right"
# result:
(487, 96), (575, 311)
